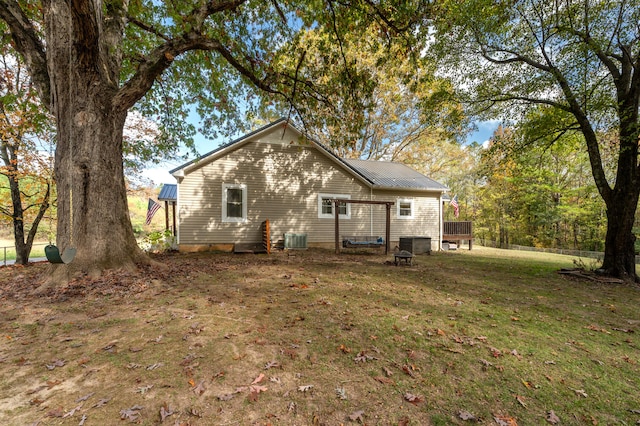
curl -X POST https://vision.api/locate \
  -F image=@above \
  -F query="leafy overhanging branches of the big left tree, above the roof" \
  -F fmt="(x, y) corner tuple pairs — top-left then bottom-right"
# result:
(121, 0), (432, 148)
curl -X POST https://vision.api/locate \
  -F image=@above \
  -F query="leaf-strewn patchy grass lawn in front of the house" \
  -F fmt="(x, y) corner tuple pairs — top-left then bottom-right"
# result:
(0, 248), (640, 425)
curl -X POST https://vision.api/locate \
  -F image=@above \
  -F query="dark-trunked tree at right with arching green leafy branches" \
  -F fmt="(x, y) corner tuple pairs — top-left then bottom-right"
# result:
(429, 0), (640, 278)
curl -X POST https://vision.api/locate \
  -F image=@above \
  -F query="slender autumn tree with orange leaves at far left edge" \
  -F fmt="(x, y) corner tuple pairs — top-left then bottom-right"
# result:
(0, 43), (54, 263)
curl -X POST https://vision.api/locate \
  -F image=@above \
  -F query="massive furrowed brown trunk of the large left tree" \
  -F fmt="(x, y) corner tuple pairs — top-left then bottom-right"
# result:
(46, 1), (149, 284)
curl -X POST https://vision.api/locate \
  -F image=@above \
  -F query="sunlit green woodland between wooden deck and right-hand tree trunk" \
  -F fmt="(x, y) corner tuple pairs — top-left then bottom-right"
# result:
(477, 124), (606, 251)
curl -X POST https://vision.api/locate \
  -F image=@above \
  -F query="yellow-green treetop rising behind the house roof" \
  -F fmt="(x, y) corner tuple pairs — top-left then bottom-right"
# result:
(268, 23), (467, 155)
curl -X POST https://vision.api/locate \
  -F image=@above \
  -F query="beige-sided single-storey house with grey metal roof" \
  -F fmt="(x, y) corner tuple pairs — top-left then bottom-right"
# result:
(170, 119), (447, 251)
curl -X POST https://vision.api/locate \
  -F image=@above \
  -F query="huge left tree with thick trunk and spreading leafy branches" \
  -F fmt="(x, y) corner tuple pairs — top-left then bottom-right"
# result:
(0, 0), (430, 281)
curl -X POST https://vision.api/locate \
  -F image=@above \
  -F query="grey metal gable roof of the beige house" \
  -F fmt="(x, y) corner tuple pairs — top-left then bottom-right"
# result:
(169, 118), (449, 192)
